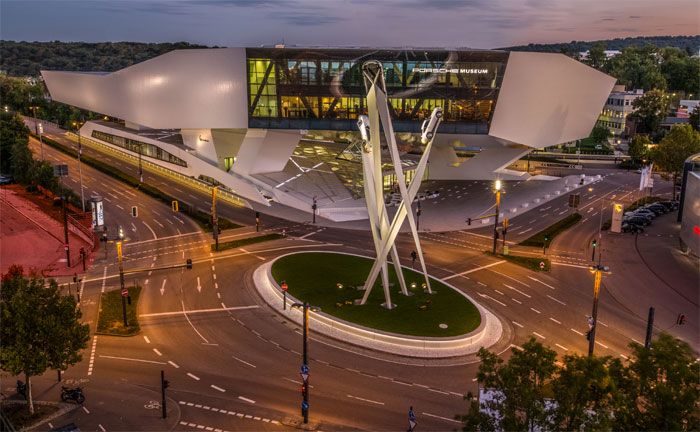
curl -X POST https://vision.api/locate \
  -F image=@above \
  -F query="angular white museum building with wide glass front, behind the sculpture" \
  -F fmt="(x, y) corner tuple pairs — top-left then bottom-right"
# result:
(42, 47), (614, 220)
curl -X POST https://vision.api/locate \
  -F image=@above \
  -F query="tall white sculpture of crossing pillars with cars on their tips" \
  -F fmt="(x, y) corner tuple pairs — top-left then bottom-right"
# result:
(357, 61), (442, 309)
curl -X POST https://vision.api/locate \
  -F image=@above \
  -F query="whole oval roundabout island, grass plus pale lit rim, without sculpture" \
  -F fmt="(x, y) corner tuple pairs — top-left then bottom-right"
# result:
(253, 252), (502, 358)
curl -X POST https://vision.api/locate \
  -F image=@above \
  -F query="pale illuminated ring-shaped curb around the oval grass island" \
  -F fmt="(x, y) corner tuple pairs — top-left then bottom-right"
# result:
(253, 251), (503, 359)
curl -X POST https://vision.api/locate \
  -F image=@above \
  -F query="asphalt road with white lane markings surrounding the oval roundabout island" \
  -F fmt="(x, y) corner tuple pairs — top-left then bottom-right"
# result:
(9, 122), (698, 430)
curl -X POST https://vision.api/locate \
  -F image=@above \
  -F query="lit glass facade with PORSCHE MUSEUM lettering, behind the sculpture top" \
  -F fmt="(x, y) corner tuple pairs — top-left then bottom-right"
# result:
(247, 48), (508, 133)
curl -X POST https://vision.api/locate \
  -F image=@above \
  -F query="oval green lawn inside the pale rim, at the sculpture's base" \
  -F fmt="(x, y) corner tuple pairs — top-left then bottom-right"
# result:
(272, 252), (481, 337)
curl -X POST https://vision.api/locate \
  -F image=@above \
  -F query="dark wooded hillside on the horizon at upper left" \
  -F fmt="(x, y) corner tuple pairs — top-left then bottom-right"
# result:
(0, 41), (207, 76)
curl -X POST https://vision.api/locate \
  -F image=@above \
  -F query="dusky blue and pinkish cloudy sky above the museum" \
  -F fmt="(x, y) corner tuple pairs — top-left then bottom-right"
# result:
(0, 0), (700, 48)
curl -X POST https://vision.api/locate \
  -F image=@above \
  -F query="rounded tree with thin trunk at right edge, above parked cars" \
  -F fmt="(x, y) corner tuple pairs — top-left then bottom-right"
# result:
(651, 124), (700, 199)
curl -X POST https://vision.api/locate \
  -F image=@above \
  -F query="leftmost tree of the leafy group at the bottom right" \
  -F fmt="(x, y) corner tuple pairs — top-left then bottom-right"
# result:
(461, 338), (557, 430)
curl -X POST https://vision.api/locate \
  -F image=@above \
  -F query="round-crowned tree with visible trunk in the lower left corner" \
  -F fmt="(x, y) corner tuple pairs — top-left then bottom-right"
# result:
(0, 266), (90, 414)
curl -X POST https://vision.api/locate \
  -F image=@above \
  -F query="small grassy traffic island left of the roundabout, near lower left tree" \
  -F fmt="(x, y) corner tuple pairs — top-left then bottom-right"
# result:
(97, 286), (141, 336)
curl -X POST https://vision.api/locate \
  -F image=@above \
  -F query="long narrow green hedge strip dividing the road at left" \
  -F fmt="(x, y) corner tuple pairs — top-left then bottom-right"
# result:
(32, 134), (240, 231)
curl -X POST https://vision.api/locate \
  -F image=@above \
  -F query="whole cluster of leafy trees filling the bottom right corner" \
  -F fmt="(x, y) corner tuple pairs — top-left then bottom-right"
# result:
(458, 333), (700, 431)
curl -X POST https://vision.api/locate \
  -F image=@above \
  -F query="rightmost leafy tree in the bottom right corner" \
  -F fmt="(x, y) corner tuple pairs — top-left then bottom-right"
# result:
(613, 333), (700, 431)
